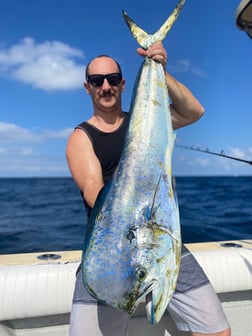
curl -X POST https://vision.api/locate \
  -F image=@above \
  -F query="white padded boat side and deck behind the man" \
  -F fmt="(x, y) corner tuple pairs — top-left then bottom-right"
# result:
(0, 240), (252, 336)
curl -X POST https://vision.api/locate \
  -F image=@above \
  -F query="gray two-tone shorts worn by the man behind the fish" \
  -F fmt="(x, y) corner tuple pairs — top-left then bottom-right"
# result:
(70, 247), (229, 336)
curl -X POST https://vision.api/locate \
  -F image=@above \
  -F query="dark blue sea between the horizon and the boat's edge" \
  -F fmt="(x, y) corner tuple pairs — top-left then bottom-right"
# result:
(0, 176), (252, 254)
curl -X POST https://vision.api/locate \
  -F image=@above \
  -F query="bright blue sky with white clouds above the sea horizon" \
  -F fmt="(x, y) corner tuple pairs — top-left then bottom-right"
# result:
(0, 0), (252, 177)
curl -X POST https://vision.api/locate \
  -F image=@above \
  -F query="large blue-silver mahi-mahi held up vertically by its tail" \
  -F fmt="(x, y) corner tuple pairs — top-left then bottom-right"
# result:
(82, 0), (184, 324)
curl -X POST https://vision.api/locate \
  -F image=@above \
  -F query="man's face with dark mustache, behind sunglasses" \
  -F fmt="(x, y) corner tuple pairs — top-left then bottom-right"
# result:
(84, 57), (125, 112)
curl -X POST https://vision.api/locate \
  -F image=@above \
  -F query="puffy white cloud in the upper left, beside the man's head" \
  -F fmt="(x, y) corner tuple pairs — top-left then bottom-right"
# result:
(0, 37), (84, 91)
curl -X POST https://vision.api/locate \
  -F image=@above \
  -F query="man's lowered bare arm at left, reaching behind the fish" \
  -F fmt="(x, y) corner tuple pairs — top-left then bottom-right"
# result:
(66, 129), (104, 208)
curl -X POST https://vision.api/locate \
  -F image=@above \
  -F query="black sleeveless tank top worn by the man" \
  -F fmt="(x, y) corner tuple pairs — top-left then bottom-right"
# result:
(76, 112), (129, 216)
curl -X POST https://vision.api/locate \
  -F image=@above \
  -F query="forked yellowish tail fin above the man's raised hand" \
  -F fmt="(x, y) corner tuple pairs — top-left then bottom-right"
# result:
(123, 0), (185, 49)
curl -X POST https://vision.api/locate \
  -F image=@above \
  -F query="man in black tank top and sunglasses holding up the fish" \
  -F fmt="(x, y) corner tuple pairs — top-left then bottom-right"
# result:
(67, 42), (230, 336)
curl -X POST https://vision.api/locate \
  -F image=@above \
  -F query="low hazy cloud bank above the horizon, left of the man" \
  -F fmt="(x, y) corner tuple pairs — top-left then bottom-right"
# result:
(0, 122), (72, 177)
